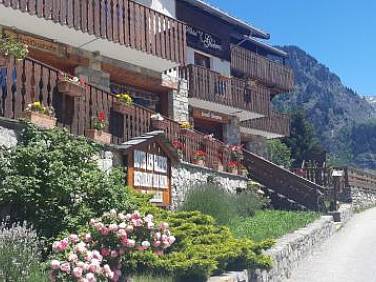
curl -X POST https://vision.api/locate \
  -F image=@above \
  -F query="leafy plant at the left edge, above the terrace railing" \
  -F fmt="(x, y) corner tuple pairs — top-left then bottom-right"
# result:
(0, 37), (29, 67)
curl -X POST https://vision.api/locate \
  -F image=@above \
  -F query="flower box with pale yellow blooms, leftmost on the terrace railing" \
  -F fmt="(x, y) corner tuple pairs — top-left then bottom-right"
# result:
(23, 101), (56, 129)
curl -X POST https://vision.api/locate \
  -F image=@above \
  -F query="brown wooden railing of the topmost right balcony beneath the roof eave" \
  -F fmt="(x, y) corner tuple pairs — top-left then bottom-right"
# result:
(231, 46), (294, 92)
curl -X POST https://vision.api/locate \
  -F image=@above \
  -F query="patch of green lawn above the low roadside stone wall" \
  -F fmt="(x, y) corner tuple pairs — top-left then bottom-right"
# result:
(229, 210), (320, 241)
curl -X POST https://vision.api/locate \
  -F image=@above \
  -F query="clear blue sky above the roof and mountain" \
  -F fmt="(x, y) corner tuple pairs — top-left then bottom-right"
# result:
(208, 0), (376, 95)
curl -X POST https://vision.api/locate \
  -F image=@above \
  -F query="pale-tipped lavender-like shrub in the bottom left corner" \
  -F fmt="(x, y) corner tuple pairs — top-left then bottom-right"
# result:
(0, 222), (43, 282)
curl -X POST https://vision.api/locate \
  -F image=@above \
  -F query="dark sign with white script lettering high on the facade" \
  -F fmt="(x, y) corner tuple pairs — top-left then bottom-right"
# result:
(187, 26), (224, 56)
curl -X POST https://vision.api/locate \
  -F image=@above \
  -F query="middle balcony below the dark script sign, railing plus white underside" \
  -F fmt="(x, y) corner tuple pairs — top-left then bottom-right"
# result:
(183, 65), (270, 120)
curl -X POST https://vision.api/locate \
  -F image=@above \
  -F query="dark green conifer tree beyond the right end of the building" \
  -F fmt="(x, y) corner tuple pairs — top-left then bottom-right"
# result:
(283, 111), (325, 167)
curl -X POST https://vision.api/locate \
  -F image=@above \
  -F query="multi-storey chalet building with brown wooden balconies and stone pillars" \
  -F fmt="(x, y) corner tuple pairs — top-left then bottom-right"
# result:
(0, 0), (302, 207)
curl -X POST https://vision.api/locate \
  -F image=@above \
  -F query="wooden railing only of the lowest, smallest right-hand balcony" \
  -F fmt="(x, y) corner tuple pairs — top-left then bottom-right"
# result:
(242, 111), (290, 136)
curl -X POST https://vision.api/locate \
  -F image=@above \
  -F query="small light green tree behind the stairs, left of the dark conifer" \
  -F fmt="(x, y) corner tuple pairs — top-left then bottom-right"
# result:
(266, 139), (292, 168)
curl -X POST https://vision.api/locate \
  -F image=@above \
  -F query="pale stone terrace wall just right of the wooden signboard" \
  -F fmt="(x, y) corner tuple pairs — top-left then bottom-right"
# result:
(171, 163), (247, 209)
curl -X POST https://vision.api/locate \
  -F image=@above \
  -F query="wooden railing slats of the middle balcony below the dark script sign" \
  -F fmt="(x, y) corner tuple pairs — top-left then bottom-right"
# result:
(182, 65), (270, 115)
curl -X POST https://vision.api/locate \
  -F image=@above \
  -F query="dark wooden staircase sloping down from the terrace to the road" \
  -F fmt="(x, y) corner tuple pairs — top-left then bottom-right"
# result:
(243, 150), (326, 211)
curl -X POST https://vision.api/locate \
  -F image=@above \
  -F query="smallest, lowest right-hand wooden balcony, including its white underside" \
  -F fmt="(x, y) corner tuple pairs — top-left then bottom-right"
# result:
(240, 112), (290, 139)
